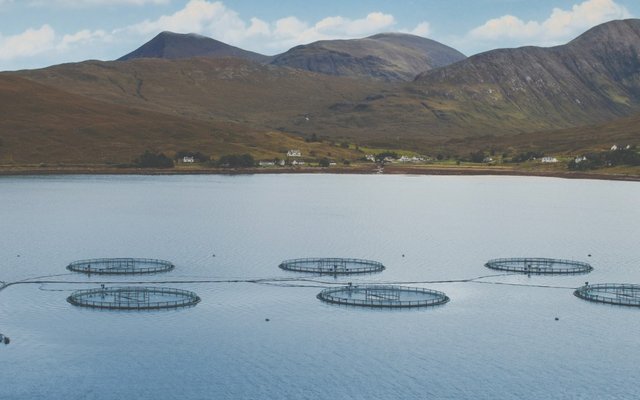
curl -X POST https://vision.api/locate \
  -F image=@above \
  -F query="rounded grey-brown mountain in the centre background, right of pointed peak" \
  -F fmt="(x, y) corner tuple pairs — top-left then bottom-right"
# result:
(271, 33), (465, 81)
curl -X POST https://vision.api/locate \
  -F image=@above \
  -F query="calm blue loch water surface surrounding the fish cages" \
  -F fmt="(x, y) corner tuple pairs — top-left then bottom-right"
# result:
(0, 175), (640, 400)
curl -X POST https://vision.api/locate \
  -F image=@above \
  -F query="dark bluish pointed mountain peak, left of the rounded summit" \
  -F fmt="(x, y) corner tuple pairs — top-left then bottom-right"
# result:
(118, 32), (271, 63)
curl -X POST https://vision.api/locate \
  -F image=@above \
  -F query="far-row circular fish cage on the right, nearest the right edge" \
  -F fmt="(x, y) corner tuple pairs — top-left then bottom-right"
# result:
(484, 258), (593, 275)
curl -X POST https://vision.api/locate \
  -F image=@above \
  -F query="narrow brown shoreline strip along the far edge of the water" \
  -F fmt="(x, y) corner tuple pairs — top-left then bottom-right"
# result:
(0, 165), (640, 182)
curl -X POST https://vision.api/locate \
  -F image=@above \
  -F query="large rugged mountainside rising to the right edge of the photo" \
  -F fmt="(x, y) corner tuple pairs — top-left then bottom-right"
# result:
(298, 19), (640, 147)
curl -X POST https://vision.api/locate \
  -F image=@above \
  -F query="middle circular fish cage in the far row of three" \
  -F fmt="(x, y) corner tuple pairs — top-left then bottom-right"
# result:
(278, 258), (385, 275)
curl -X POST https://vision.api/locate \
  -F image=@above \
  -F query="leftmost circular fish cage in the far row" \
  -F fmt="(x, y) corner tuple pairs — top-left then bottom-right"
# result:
(67, 258), (175, 275)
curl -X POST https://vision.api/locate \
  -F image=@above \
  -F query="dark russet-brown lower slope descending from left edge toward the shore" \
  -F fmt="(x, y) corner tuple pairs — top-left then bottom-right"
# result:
(0, 74), (352, 164)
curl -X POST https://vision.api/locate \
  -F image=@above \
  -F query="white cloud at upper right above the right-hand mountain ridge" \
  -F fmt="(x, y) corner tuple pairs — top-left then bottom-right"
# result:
(467, 0), (631, 45)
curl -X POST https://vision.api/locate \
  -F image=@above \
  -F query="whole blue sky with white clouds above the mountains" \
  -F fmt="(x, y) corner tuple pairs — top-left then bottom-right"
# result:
(0, 0), (640, 71)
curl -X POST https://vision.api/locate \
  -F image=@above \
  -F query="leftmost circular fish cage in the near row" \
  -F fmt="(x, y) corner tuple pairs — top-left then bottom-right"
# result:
(67, 286), (200, 310)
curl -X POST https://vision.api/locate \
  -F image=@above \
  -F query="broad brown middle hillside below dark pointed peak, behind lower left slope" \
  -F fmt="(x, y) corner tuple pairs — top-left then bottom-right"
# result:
(18, 57), (385, 136)
